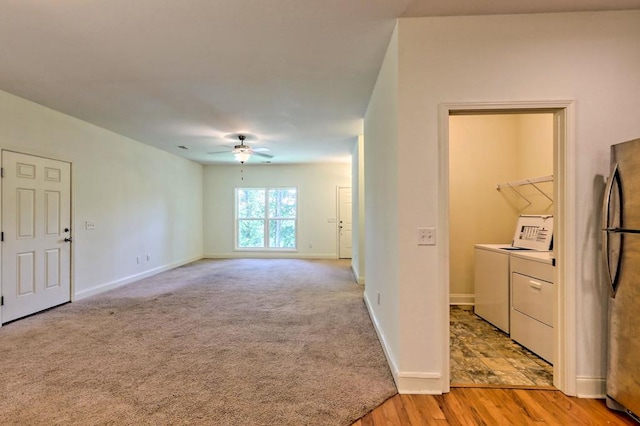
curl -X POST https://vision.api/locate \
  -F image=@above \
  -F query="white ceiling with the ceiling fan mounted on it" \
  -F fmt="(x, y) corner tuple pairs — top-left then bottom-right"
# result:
(0, 0), (640, 164)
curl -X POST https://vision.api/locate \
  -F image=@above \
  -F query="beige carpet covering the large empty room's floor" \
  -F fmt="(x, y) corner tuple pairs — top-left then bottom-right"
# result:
(0, 259), (396, 425)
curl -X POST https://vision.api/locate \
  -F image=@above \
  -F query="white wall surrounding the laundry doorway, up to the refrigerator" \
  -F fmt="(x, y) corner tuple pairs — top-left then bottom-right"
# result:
(365, 11), (640, 393)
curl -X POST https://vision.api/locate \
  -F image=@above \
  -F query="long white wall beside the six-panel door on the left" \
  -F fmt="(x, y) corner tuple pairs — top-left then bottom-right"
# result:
(0, 92), (202, 299)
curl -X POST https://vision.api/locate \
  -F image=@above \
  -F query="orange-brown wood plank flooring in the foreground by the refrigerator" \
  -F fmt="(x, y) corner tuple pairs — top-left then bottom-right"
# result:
(352, 387), (638, 426)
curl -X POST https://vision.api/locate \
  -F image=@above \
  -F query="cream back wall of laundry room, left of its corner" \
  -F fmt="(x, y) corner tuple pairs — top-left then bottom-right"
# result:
(449, 115), (518, 304)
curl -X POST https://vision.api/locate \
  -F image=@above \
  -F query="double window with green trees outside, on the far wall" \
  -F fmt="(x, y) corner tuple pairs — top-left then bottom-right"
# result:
(236, 188), (298, 249)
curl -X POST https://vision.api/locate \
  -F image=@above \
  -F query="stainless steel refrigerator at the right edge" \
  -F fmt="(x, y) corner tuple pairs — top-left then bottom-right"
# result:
(602, 139), (640, 420)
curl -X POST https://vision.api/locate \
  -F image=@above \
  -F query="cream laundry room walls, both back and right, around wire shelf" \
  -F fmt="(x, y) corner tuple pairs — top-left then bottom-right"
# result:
(449, 114), (553, 304)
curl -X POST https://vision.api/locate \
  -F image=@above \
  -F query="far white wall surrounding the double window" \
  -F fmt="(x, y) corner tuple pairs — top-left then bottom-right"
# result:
(204, 163), (351, 259)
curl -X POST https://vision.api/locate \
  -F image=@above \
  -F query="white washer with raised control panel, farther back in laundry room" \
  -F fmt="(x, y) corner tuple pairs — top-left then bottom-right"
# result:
(474, 215), (553, 334)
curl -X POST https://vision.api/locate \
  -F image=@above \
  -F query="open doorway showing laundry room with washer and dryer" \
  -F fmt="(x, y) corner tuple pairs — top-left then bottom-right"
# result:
(448, 110), (558, 387)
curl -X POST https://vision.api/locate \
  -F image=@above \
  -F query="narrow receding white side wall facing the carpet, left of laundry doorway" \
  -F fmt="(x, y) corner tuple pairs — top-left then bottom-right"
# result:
(364, 28), (400, 377)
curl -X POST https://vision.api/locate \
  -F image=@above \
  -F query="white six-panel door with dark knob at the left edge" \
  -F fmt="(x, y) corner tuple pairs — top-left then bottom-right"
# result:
(2, 151), (71, 323)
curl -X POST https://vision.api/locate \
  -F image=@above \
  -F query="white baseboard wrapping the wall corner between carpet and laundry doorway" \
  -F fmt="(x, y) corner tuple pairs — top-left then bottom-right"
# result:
(364, 293), (442, 395)
